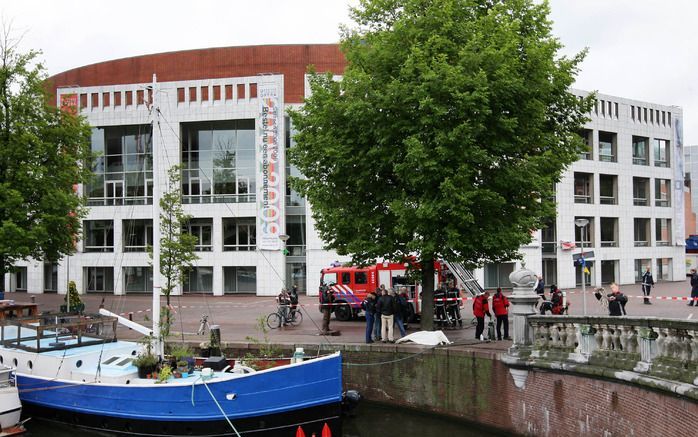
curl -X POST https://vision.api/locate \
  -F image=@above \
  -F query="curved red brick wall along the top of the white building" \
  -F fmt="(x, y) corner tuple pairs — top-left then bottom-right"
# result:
(49, 44), (346, 103)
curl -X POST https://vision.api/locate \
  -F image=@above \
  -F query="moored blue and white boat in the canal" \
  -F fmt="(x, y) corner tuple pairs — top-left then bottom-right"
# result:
(0, 316), (342, 436)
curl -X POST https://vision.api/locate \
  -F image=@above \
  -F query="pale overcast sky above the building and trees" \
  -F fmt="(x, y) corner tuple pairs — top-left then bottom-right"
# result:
(0, 0), (698, 145)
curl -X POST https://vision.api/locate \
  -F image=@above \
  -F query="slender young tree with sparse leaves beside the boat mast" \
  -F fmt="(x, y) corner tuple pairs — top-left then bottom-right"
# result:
(148, 165), (198, 338)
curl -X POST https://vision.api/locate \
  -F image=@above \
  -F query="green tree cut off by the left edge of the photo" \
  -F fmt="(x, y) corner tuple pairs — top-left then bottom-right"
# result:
(0, 27), (91, 291)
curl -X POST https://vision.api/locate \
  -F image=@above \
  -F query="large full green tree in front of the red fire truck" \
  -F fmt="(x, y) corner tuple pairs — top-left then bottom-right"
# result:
(289, 0), (591, 329)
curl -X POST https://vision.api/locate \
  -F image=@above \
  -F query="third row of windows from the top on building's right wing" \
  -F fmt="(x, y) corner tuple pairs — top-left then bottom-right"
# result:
(541, 217), (672, 249)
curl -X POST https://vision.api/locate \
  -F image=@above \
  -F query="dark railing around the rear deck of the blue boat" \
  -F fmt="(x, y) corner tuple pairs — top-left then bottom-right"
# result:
(0, 314), (117, 353)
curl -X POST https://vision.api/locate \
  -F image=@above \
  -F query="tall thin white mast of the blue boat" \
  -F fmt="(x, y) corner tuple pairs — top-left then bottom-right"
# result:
(150, 73), (164, 355)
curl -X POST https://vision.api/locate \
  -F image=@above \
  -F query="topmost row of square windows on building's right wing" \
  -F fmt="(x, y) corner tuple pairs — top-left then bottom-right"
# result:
(579, 129), (671, 167)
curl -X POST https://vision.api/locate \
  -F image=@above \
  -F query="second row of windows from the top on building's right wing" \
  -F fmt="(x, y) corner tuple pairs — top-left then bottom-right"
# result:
(574, 172), (672, 207)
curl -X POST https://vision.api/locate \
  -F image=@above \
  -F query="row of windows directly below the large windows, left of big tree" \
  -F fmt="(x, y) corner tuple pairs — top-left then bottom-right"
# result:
(83, 215), (306, 256)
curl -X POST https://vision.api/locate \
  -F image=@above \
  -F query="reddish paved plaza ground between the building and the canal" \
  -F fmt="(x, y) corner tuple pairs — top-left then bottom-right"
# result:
(5, 280), (698, 350)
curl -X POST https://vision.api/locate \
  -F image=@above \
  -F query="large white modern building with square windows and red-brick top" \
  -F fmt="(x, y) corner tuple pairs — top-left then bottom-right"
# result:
(5, 45), (684, 295)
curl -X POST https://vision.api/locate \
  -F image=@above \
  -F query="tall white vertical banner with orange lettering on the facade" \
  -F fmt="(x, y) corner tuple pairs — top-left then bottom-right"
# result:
(257, 82), (285, 250)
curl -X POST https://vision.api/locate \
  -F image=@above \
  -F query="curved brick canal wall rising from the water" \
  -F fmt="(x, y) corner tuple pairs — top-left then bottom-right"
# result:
(219, 345), (698, 437)
